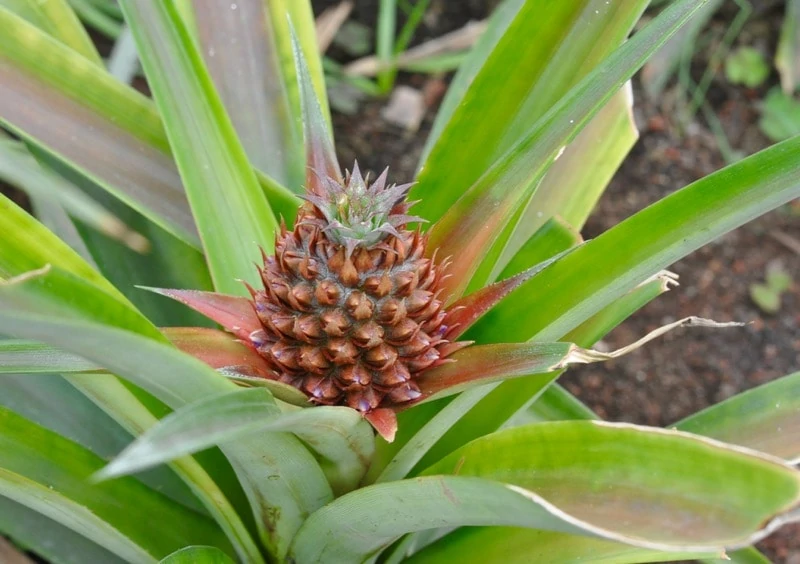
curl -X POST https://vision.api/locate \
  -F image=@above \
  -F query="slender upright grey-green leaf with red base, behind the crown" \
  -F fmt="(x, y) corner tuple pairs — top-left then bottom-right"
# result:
(292, 24), (343, 193)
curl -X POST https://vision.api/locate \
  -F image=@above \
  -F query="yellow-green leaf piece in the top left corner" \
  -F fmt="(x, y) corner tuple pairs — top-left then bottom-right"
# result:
(0, 0), (103, 63)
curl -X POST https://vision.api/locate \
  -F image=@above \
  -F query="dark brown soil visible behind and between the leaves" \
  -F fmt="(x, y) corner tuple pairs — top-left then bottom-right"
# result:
(315, 0), (800, 563)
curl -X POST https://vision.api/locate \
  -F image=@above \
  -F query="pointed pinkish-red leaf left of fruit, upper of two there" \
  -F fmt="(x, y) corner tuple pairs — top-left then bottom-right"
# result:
(147, 286), (262, 343)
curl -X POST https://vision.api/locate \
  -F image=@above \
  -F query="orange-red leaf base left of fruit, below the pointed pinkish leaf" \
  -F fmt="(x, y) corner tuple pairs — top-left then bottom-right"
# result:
(161, 327), (273, 378)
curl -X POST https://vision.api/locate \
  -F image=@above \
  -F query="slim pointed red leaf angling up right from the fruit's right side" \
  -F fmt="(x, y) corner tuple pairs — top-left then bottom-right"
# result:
(444, 249), (572, 334)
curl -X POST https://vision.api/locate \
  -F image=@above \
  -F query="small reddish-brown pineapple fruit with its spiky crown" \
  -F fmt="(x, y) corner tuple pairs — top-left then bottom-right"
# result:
(250, 163), (460, 413)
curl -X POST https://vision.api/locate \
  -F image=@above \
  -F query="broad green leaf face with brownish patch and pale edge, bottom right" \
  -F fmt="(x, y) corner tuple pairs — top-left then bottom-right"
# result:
(425, 421), (800, 547)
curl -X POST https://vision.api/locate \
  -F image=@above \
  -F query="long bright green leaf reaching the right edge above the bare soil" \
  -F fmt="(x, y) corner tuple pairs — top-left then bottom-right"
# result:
(473, 138), (800, 342)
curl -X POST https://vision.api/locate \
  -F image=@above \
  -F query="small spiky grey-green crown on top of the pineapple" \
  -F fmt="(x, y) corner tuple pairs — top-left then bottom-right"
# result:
(303, 162), (425, 256)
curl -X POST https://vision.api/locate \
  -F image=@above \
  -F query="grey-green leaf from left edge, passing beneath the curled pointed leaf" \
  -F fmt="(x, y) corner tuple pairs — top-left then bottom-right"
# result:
(0, 292), (332, 561)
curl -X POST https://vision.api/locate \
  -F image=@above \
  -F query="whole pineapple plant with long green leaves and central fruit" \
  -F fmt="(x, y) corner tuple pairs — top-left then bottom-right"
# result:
(0, 0), (800, 563)
